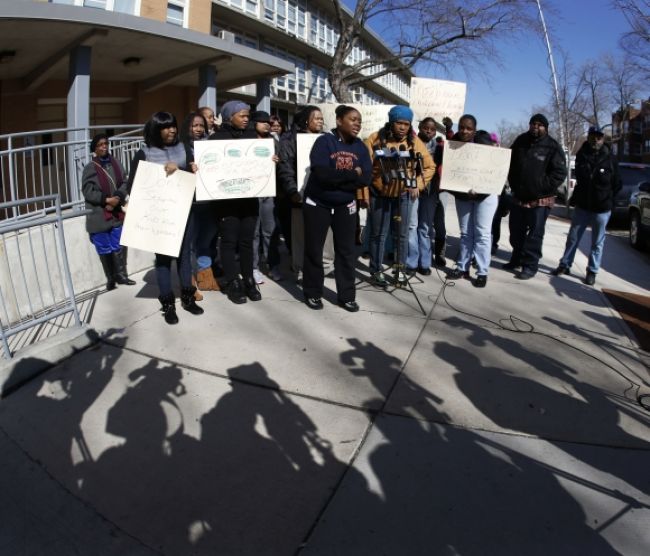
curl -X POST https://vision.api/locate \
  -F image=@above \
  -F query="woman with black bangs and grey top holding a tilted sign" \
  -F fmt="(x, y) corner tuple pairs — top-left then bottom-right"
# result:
(129, 112), (203, 324)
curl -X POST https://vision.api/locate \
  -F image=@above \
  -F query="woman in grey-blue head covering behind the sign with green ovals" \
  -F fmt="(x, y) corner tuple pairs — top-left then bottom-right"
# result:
(210, 100), (262, 304)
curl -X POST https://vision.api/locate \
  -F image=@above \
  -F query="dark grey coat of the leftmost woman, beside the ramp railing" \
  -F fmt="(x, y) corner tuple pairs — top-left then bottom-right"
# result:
(81, 155), (127, 234)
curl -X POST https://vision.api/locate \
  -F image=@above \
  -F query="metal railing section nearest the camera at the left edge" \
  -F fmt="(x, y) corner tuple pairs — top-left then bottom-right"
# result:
(0, 195), (86, 358)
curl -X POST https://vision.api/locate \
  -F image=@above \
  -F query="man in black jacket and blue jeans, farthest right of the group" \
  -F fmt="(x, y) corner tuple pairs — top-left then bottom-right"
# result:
(552, 126), (621, 286)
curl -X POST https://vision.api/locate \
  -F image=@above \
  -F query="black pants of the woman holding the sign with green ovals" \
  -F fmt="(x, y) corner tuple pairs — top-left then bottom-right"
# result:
(217, 198), (259, 284)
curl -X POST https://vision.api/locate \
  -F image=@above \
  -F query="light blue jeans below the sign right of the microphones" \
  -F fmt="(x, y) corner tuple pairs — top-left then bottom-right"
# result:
(456, 195), (499, 276)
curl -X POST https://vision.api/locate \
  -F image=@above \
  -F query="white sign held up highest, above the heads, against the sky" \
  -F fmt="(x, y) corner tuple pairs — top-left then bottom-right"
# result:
(410, 77), (467, 122)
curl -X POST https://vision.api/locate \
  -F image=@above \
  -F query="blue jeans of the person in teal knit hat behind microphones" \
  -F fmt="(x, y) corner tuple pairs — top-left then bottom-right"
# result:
(370, 193), (409, 274)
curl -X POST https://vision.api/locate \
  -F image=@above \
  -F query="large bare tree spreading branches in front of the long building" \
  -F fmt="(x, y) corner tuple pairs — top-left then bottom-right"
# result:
(328, 0), (530, 102)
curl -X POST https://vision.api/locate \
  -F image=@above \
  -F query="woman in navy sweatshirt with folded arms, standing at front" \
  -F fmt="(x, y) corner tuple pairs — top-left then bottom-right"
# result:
(302, 105), (372, 312)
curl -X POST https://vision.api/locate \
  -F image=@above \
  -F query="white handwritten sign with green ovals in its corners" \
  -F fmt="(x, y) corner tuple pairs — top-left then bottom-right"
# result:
(194, 139), (275, 201)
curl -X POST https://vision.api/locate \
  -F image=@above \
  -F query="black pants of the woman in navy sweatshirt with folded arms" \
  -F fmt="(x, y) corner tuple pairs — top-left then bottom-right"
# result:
(302, 202), (357, 303)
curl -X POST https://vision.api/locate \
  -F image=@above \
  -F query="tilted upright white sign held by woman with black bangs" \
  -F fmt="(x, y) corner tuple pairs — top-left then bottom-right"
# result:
(120, 161), (196, 257)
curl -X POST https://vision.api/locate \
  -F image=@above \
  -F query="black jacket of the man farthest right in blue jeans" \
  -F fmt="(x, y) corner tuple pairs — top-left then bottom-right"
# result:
(571, 142), (622, 212)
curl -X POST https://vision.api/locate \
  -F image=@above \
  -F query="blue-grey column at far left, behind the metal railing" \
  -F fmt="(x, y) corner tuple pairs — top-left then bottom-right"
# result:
(66, 46), (92, 202)
